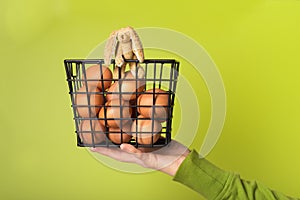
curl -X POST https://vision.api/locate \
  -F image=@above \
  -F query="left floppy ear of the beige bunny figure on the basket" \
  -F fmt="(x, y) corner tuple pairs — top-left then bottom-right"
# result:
(104, 31), (118, 65)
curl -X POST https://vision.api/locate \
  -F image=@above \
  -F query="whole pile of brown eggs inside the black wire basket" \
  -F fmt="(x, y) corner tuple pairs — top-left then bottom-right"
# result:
(75, 65), (169, 145)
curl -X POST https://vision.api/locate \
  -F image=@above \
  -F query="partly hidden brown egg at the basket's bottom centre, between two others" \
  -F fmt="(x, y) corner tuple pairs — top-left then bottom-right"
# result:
(108, 122), (132, 144)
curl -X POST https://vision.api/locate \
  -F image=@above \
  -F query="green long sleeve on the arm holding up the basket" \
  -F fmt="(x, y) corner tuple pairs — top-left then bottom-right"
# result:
(174, 150), (295, 200)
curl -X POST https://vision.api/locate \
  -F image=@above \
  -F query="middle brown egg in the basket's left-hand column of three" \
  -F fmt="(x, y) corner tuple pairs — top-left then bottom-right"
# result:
(75, 86), (104, 117)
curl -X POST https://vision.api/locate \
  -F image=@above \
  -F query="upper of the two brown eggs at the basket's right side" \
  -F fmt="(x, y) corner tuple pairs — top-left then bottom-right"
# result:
(137, 88), (169, 122)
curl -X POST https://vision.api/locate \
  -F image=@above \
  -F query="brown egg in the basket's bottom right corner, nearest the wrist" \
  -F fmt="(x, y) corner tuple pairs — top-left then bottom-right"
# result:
(131, 115), (162, 144)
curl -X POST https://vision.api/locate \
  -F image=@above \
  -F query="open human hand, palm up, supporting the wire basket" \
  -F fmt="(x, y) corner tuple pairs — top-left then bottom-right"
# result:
(90, 140), (190, 176)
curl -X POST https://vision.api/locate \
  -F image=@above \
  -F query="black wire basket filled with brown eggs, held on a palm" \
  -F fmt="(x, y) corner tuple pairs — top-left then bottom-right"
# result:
(64, 59), (179, 148)
